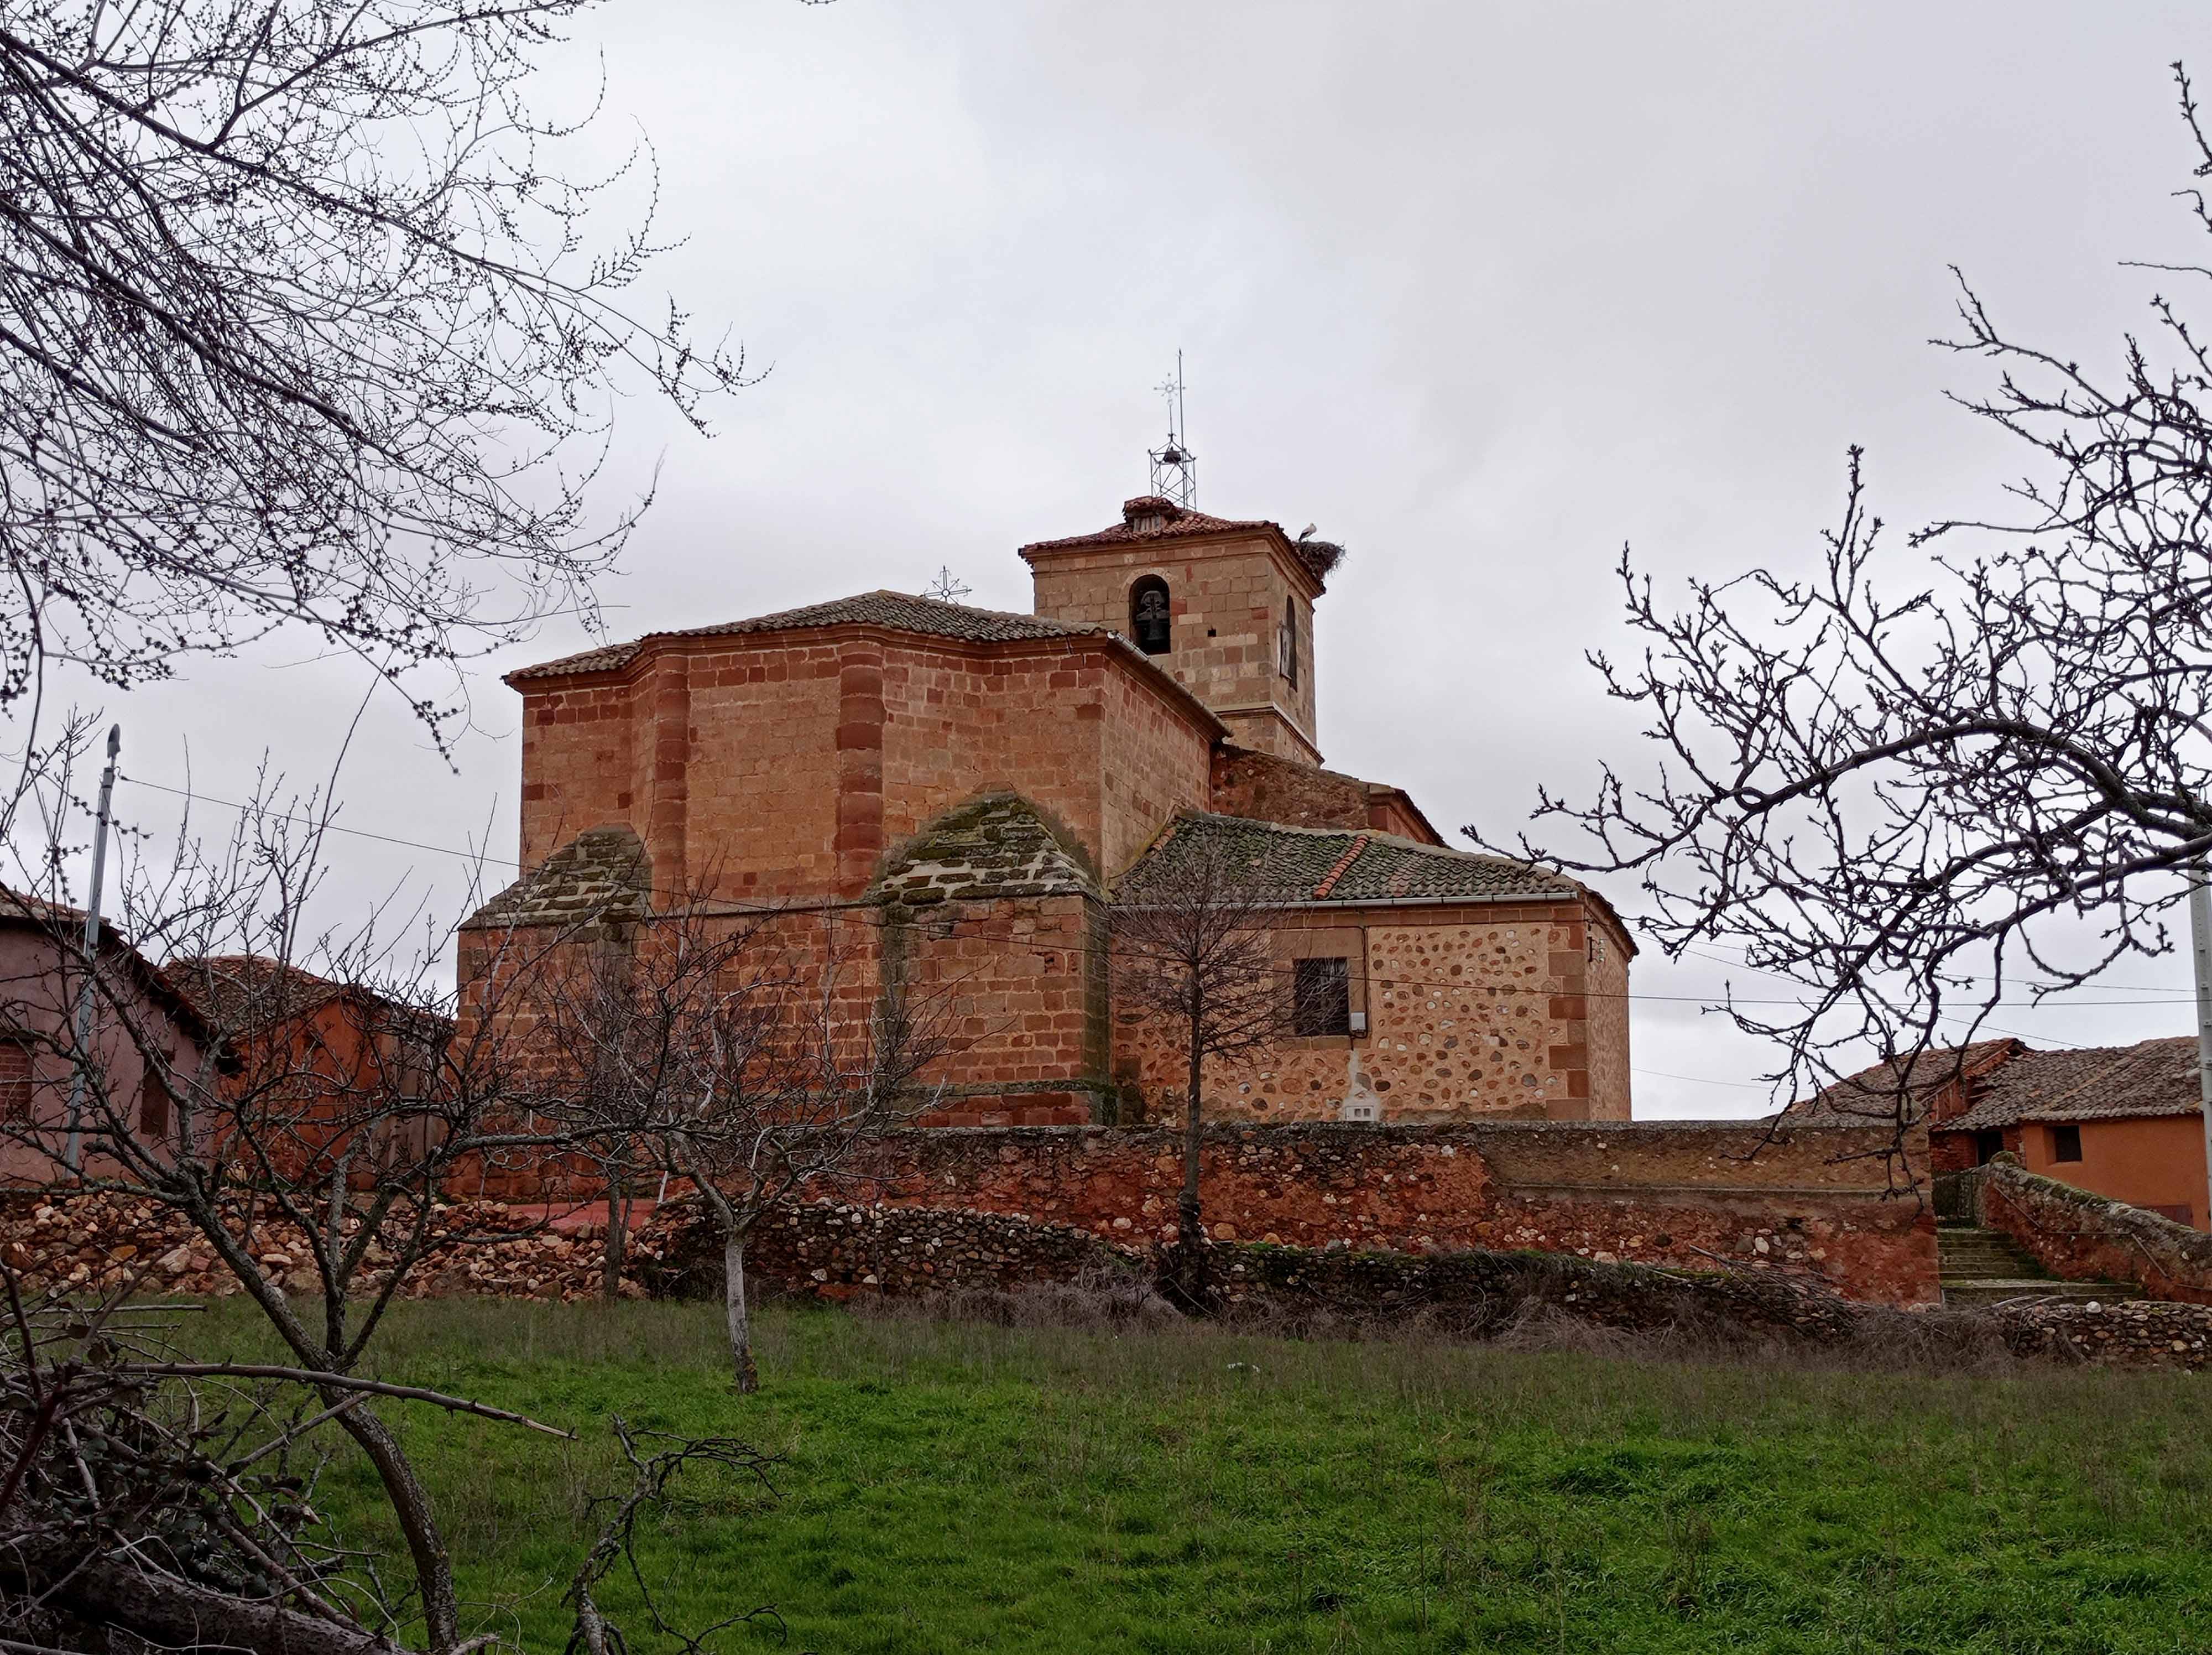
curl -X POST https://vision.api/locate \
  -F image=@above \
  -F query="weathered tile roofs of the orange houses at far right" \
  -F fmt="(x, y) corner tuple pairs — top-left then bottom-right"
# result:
(1783, 1035), (2201, 1133)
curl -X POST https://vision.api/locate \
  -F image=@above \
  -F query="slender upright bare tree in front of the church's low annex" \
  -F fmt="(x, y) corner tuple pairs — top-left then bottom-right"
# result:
(1113, 823), (1292, 1301)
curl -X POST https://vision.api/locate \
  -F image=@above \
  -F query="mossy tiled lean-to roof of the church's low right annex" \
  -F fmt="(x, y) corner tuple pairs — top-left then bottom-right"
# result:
(1115, 812), (1588, 907)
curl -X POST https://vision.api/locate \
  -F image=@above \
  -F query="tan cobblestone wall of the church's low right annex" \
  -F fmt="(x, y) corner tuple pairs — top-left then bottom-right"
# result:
(1115, 903), (1628, 1122)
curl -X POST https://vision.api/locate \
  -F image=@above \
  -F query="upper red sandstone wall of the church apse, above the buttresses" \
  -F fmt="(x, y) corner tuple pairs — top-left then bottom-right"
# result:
(522, 626), (1219, 898)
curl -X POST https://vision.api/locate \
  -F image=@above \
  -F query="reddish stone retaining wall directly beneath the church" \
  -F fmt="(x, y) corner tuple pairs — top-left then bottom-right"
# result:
(836, 1122), (1940, 1303)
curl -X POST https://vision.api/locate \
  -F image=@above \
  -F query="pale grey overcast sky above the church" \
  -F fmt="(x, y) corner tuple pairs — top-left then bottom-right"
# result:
(56, 0), (2212, 1117)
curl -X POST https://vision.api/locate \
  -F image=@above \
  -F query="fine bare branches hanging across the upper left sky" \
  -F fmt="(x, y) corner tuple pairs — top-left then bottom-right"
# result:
(0, 0), (741, 728)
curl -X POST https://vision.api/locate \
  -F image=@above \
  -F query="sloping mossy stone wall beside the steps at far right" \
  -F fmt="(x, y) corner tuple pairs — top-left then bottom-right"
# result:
(1982, 1159), (2212, 1305)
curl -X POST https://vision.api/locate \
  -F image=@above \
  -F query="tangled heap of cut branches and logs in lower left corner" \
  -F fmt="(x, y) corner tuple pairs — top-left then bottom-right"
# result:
(0, 1270), (776, 1655)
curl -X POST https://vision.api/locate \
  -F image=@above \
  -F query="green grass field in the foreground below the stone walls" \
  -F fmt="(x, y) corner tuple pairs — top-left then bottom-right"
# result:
(215, 1301), (2212, 1655)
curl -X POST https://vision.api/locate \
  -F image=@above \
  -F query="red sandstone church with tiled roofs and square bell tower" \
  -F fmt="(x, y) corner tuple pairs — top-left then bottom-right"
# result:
(460, 496), (1635, 1124)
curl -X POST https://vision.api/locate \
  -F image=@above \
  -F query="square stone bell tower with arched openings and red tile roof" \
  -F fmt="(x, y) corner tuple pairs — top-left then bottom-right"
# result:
(1022, 493), (1343, 763)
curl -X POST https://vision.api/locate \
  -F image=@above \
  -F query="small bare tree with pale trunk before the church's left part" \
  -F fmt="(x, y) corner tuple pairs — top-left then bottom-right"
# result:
(538, 898), (951, 1392)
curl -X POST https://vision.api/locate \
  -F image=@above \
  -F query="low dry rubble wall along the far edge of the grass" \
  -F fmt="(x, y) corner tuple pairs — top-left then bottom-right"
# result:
(0, 1195), (2212, 1372)
